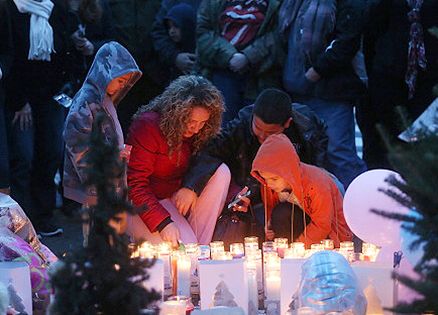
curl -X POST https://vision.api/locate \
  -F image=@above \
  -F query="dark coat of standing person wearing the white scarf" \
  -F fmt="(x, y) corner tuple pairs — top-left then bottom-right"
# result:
(0, 0), (67, 111)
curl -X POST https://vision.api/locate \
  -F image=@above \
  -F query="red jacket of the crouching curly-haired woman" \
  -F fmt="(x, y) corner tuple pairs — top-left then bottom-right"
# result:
(127, 112), (192, 232)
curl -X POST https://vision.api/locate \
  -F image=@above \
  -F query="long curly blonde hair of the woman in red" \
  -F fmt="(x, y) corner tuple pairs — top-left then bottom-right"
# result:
(133, 75), (224, 154)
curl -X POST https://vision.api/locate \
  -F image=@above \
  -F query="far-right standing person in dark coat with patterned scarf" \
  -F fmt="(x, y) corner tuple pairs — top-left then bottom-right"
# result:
(358, 0), (438, 168)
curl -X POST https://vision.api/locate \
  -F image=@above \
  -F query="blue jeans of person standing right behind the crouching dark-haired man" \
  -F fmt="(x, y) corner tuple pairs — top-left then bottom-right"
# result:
(296, 97), (367, 189)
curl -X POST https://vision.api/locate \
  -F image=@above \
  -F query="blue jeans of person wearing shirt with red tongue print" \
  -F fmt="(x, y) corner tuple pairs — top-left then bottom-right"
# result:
(211, 70), (250, 126)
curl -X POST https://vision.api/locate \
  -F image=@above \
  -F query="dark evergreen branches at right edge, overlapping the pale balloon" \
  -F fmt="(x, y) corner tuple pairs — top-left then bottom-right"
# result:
(372, 114), (438, 314)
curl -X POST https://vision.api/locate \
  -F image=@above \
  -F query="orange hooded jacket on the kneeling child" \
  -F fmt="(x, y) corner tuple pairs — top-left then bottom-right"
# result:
(251, 134), (353, 247)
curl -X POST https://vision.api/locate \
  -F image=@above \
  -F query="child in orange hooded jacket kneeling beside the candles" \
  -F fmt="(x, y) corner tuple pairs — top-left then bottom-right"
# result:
(251, 134), (353, 247)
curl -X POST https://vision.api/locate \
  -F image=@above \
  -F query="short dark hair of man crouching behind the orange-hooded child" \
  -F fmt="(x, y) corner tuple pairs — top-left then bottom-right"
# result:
(253, 89), (292, 125)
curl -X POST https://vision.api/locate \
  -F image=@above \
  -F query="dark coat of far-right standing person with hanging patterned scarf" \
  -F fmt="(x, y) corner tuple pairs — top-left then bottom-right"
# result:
(364, 0), (438, 116)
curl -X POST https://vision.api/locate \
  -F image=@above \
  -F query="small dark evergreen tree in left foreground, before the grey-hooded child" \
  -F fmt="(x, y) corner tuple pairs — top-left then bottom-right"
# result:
(50, 116), (158, 315)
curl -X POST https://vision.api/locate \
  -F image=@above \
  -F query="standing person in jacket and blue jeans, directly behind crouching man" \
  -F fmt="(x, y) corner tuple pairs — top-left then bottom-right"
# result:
(279, 0), (367, 188)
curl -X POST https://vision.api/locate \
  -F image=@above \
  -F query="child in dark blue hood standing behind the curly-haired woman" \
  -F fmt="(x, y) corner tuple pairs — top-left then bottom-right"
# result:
(164, 3), (196, 80)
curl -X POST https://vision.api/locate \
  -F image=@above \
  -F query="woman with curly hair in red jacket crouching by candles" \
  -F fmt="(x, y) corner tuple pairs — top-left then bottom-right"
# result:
(127, 75), (230, 245)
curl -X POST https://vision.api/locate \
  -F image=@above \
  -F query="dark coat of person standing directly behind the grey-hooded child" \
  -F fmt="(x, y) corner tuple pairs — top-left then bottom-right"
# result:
(67, 0), (115, 93)
